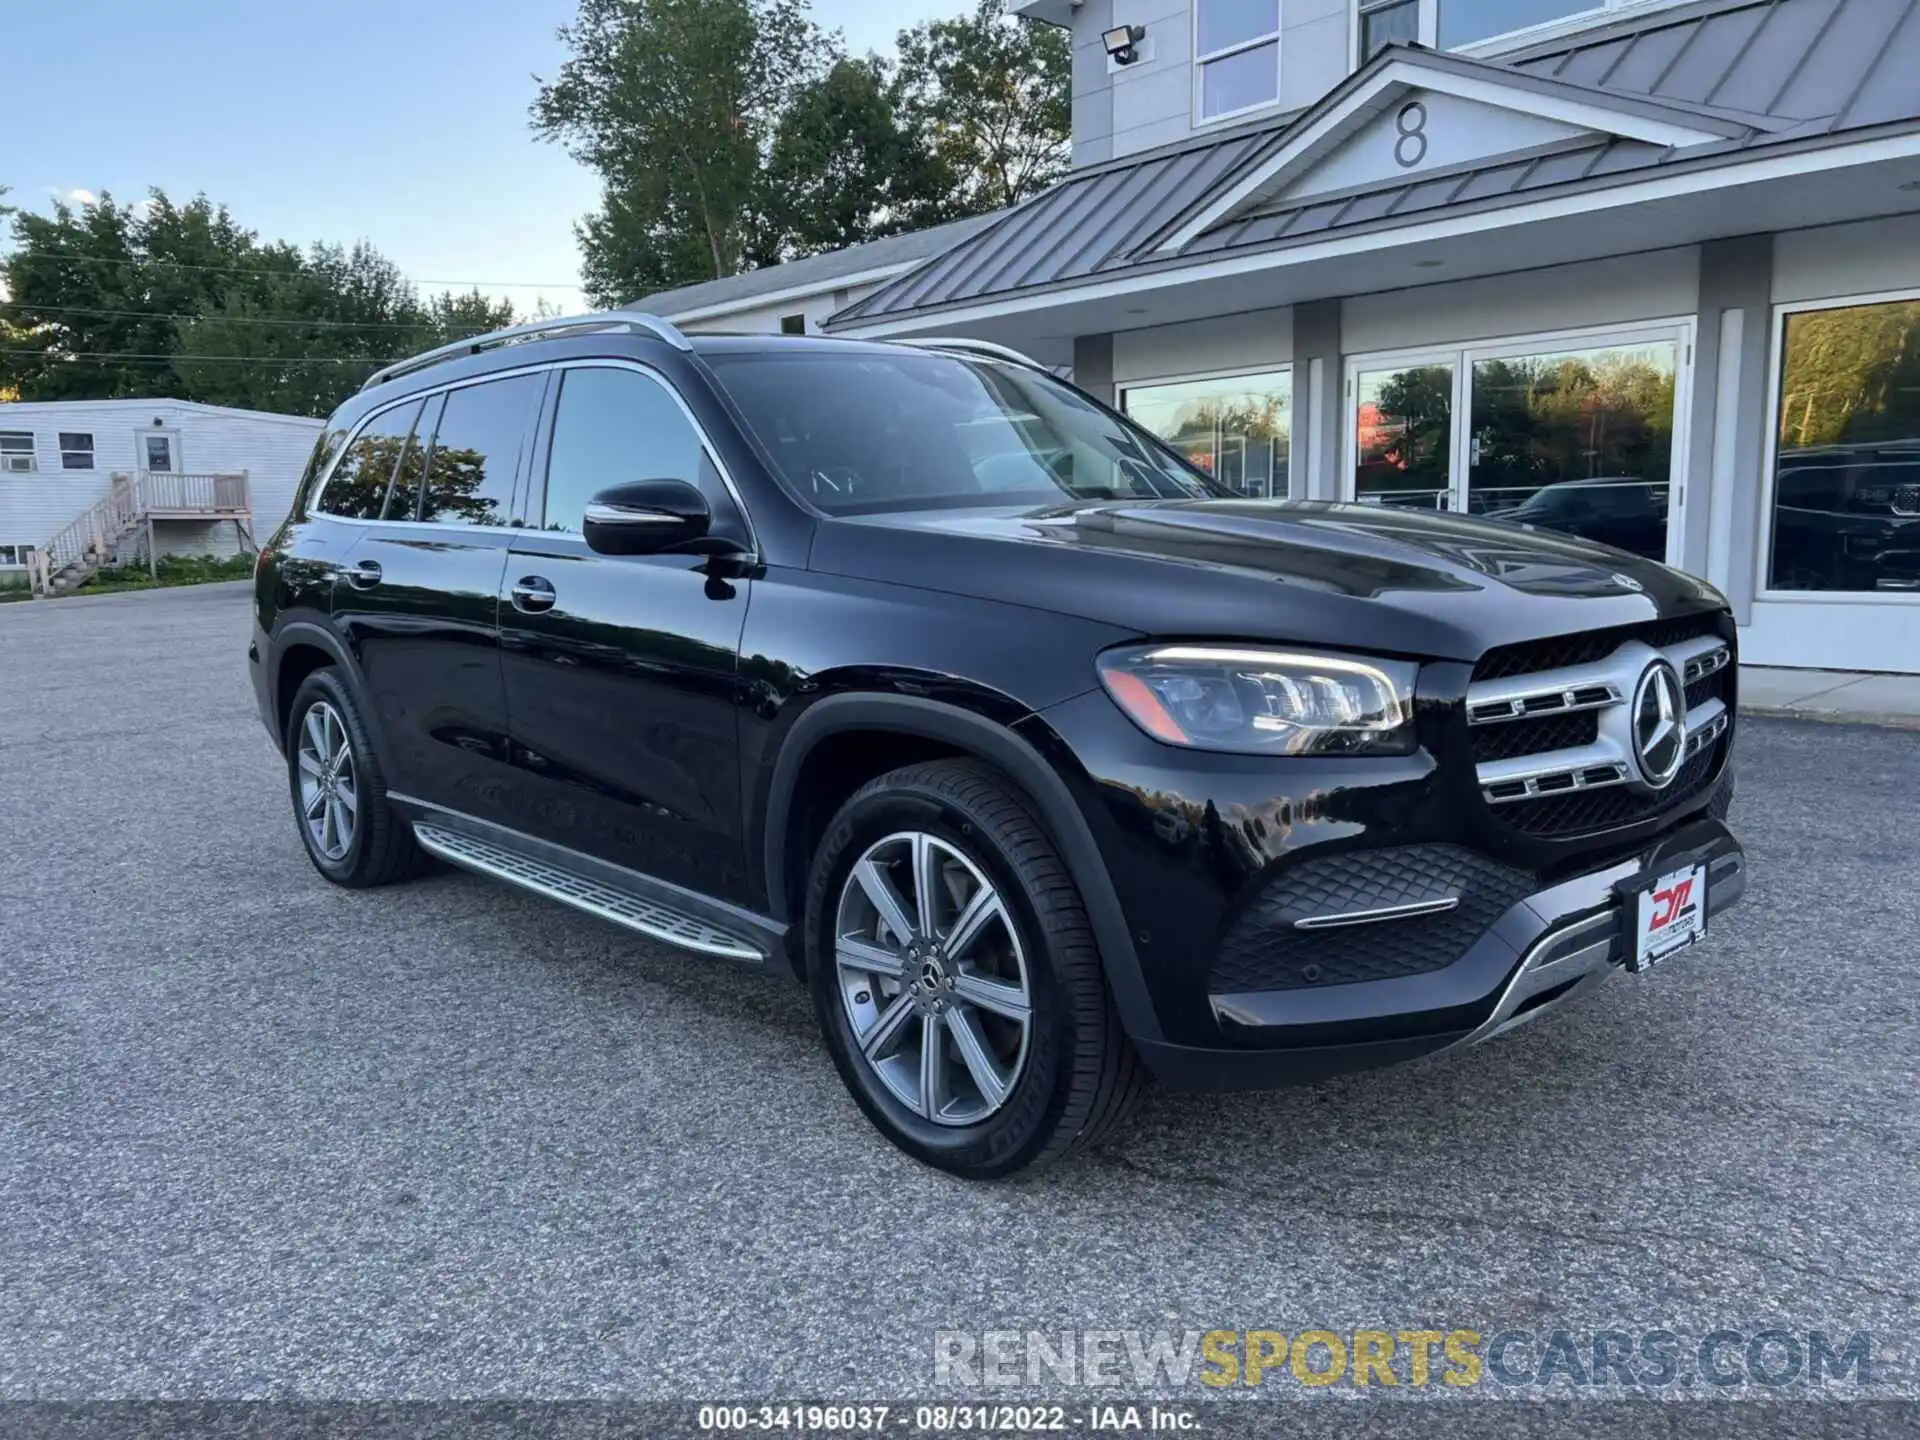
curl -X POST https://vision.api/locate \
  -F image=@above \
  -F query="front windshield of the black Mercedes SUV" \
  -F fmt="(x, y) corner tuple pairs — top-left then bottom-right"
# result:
(707, 349), (1227, 515)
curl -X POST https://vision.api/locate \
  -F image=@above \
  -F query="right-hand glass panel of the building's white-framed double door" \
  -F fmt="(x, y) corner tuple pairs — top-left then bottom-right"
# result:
(1465, 340), (1680, 561)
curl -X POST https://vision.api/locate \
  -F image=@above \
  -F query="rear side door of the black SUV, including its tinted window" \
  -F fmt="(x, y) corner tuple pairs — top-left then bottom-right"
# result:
(326, 372), (545, 820)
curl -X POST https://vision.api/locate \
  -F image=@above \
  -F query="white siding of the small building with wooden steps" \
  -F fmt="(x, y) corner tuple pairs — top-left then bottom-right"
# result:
(0, 399), (321, 553)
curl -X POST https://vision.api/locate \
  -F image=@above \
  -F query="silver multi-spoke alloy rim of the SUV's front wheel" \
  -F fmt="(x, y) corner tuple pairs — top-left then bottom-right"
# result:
(833, 831), (1033, 1125)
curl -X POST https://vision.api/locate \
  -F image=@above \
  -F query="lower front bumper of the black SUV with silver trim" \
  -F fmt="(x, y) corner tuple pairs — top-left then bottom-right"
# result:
(1135, 820), (1747, 1091)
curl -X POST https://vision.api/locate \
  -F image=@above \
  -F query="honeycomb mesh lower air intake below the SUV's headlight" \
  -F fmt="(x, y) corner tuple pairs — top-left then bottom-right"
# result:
(1208, 845), (1536, 995)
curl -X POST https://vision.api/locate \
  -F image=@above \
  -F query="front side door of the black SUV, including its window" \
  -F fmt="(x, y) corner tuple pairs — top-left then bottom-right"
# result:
(499, 361), (753, 902)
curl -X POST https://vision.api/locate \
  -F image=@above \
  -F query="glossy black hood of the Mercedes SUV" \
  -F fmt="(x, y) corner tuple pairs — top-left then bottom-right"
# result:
(810, 499), (1724, 660)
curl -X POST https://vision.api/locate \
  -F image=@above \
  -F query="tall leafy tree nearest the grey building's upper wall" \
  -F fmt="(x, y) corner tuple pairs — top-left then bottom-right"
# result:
(900, 0), (1073, 215)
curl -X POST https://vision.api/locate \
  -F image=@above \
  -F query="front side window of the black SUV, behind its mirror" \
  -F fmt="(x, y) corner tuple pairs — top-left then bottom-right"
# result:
(543, 371), (720, 530)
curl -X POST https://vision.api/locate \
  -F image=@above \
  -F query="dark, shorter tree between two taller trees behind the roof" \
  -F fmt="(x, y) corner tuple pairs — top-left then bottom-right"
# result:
(760, 56), (954, 261)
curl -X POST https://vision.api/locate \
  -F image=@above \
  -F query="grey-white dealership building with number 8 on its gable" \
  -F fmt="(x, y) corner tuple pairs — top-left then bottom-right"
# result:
(633, 0), (1920, 672)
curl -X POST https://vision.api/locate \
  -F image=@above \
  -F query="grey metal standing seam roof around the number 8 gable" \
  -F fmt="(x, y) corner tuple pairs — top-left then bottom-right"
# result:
(828, 0), (1920, 328)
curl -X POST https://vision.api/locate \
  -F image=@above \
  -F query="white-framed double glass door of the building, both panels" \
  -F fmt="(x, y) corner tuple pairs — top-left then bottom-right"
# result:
(1346, 324), (1690, 564)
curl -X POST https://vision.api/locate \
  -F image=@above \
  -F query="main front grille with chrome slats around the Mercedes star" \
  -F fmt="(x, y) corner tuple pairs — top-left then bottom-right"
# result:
(1465, 612), (1736, 839)
